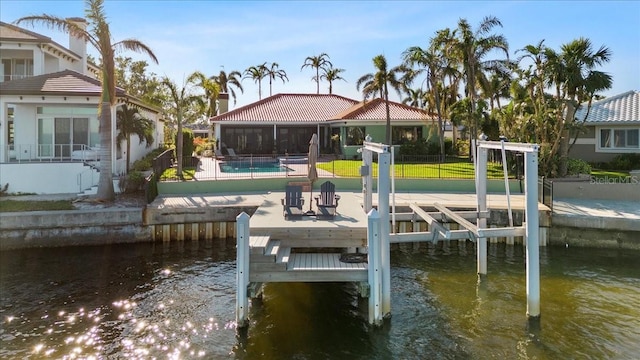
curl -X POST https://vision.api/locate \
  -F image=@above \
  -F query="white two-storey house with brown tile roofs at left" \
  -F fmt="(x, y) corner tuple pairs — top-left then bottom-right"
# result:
(0, 18), (164, 194)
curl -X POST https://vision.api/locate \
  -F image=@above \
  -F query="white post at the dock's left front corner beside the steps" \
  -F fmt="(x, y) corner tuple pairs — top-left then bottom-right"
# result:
(236, 212), (250, 327)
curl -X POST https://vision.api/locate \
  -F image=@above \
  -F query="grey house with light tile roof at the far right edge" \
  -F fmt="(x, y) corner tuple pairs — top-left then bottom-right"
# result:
(569, 91), (640, 163)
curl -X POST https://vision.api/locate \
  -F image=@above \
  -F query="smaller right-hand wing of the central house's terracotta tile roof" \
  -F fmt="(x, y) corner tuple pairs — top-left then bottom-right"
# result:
(336, 98), (436, 120)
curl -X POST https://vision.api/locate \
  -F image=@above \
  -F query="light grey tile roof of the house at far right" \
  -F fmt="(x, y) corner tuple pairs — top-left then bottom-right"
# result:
(576, 90), (640, 124)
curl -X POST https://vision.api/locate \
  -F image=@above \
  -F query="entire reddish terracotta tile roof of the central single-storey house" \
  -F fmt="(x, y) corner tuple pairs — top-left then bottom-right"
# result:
(210, 94), (433, 123)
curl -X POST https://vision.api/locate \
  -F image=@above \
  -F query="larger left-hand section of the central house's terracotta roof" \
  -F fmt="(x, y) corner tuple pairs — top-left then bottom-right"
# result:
(210, 94), (357, 123)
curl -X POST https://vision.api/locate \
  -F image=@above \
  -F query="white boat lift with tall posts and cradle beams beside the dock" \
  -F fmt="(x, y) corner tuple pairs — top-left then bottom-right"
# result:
(360, 138), (540, 324)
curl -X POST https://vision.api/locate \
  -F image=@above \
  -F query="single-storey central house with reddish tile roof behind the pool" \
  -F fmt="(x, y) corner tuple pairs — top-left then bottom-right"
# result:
(211, 94), (437, 158)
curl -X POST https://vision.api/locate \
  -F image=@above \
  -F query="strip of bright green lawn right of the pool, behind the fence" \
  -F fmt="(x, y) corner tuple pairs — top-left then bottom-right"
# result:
(318, 160), (504, 179)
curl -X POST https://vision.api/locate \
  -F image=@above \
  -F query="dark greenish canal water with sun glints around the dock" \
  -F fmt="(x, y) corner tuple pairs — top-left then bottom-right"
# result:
(0, 239), (640, 359)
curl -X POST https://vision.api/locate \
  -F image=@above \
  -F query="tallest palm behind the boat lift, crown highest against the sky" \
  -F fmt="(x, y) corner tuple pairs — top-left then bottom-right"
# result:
(454, 16), (509, 146)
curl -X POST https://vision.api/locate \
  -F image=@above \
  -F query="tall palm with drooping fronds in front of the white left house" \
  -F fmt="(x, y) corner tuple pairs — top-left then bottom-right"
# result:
(16, 0), (158, 201)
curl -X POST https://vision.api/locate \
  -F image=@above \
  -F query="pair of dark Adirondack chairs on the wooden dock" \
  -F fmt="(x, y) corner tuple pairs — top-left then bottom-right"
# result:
(282, 181), (340, 219)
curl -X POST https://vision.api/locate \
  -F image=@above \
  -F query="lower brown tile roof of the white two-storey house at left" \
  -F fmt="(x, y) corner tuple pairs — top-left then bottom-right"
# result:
(0, 70), (125, 96)
